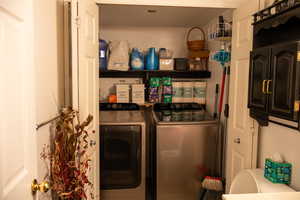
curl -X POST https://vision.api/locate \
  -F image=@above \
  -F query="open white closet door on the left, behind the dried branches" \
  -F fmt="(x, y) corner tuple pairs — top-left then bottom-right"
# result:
(71, 0), (100, 199)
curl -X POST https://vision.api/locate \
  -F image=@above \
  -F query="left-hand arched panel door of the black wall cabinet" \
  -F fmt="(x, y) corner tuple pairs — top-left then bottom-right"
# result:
(248, 48), (270, 112)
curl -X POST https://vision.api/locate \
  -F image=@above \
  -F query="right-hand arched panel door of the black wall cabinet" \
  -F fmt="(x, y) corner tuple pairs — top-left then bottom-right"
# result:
(268, 43), (298, 120)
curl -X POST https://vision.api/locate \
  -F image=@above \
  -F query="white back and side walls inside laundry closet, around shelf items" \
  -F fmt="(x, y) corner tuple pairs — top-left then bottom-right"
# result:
(100, 10), (232, 106)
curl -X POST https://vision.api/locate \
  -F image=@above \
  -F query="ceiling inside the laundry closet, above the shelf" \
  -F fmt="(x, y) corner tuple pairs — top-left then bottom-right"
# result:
(100, 4), (228, 27)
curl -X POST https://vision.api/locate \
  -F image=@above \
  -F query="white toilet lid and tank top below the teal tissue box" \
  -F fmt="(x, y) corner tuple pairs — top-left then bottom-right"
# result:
(229, 169), (295, 194)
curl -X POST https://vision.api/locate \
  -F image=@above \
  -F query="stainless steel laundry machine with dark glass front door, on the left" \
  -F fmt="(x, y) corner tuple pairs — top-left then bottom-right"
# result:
(100, 104), (146, 200)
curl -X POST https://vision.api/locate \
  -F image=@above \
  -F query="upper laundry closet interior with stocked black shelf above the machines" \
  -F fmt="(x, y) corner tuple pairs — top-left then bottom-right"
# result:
(99, 4), (232, 112)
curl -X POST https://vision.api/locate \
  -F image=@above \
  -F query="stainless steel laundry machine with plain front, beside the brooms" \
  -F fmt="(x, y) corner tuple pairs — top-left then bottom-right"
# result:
(151, 104), (218, 200)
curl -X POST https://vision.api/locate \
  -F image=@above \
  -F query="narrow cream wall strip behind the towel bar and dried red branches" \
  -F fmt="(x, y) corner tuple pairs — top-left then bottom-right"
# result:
(34, 0), (63, 199)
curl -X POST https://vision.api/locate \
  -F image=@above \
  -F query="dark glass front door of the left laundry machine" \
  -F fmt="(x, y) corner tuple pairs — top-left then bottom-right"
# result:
(100, 125), (142, 190)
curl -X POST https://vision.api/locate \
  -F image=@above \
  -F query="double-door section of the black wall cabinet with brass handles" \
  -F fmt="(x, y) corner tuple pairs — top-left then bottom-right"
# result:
(248, 42), (300, 125)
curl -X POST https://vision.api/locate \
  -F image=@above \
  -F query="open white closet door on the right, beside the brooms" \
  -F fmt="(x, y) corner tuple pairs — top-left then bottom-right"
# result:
(226, 0), (260, 193)
